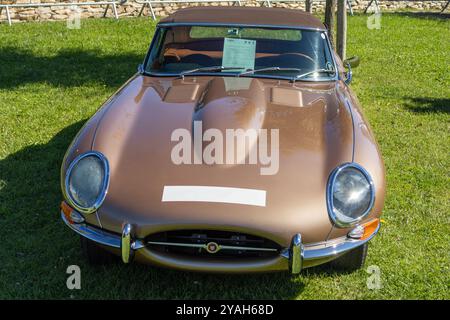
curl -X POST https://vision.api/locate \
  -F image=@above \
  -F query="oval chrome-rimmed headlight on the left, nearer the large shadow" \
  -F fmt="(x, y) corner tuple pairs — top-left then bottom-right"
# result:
(65, 152), (109, 213)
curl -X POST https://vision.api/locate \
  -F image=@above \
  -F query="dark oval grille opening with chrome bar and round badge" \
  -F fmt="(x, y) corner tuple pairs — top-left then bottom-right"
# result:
(146, 230), (281, 259)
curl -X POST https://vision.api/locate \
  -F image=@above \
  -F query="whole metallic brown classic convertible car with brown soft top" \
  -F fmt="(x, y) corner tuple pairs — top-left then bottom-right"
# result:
(61, 7), (385, 274)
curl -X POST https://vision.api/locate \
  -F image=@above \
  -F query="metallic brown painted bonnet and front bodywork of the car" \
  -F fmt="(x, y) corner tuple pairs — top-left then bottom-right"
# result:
(62, 8), (385, 270)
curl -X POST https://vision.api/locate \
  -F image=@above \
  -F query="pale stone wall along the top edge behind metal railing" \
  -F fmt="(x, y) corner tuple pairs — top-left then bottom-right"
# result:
(0, 0), (447, 23)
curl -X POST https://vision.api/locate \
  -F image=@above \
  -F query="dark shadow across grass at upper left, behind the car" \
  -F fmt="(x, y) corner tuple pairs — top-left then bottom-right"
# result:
(0, 47), (144, 89)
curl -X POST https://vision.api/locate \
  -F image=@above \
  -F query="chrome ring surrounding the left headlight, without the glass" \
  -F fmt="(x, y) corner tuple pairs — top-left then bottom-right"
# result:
(63, 151), (109, 214)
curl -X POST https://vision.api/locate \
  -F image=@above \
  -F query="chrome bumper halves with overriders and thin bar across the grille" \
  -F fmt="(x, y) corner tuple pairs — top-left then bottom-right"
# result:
(61, 212), (380, 274)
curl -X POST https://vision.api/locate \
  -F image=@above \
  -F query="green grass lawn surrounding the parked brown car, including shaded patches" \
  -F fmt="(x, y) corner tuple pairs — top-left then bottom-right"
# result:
(0, 13), (450, 299)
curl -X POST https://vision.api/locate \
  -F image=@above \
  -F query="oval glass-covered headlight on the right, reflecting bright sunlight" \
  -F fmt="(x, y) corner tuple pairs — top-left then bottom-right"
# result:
(327, 163), (375, 227)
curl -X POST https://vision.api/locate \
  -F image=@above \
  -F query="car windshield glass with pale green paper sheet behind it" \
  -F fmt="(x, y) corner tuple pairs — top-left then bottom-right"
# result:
(145, 25), (336, 81)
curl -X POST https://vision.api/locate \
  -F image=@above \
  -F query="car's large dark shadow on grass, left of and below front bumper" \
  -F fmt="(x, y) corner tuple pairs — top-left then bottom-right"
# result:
(0, 120), (305, 299)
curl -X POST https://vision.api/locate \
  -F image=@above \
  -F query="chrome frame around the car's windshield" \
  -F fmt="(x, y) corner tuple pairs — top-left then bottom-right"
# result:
(140, 22), (340, 83)
